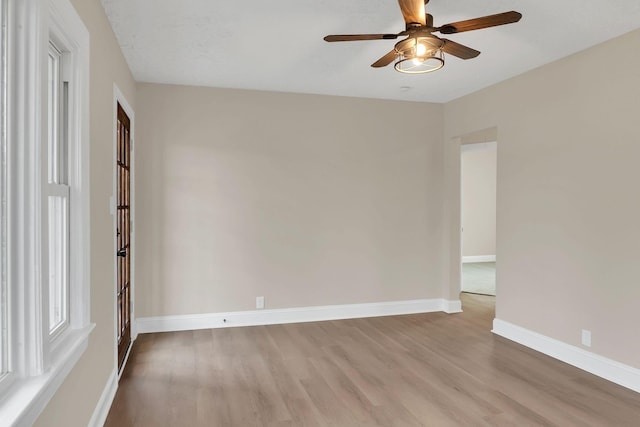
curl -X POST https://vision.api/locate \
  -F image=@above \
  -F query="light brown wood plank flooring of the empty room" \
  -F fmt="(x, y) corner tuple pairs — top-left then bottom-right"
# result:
(105, 294), (640, 427)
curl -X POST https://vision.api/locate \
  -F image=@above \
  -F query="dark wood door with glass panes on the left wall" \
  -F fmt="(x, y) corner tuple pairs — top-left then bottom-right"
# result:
(116, 104), (131, 369)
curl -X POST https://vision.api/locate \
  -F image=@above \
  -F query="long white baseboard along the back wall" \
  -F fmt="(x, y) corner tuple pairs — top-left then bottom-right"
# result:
(136, 298), (461, 334)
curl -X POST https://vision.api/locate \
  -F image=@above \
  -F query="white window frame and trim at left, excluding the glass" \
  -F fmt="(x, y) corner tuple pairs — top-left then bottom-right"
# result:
(0, 0), (95, 426)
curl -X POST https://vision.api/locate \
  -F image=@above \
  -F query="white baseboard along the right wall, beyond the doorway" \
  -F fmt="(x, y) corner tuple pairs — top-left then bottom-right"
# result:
(492, 319), (640, 393)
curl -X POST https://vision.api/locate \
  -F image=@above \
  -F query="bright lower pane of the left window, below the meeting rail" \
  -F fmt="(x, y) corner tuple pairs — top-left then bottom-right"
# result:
(49, 196), (68, 333)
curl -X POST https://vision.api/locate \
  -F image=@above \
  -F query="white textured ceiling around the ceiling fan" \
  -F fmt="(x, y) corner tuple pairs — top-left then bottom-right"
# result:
(102, 0), (640, 102)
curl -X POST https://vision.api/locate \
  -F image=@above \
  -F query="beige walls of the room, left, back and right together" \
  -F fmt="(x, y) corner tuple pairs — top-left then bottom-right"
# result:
(36, 5), (640, 426)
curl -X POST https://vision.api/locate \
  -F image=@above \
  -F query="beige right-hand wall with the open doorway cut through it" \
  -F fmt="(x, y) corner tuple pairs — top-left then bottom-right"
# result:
(444, 31), (640, 368)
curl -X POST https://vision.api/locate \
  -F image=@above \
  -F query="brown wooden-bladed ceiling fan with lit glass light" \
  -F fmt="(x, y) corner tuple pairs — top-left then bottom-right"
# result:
(324, 0), (522, 74)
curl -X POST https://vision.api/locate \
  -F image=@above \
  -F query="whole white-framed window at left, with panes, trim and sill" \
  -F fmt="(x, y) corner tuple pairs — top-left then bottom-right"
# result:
(0, 0), (93, 425)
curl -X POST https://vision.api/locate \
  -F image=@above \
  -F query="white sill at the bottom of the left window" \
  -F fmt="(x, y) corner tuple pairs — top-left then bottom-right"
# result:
(0, 324), (95, 426)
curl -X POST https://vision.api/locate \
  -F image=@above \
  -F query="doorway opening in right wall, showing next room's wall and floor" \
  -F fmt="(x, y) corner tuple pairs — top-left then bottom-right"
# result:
(460, 142), (497, 296)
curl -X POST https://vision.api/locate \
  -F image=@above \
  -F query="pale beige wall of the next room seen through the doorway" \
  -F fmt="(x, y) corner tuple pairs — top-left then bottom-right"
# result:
(461, 143), (496, 257)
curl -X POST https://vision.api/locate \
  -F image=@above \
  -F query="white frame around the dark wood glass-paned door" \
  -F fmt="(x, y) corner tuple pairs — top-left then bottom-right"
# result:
(110, 83), (138, 379)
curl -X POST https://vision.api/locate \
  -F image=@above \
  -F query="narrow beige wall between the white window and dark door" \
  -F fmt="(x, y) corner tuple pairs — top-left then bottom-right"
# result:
(36, 0), (135, 427)
